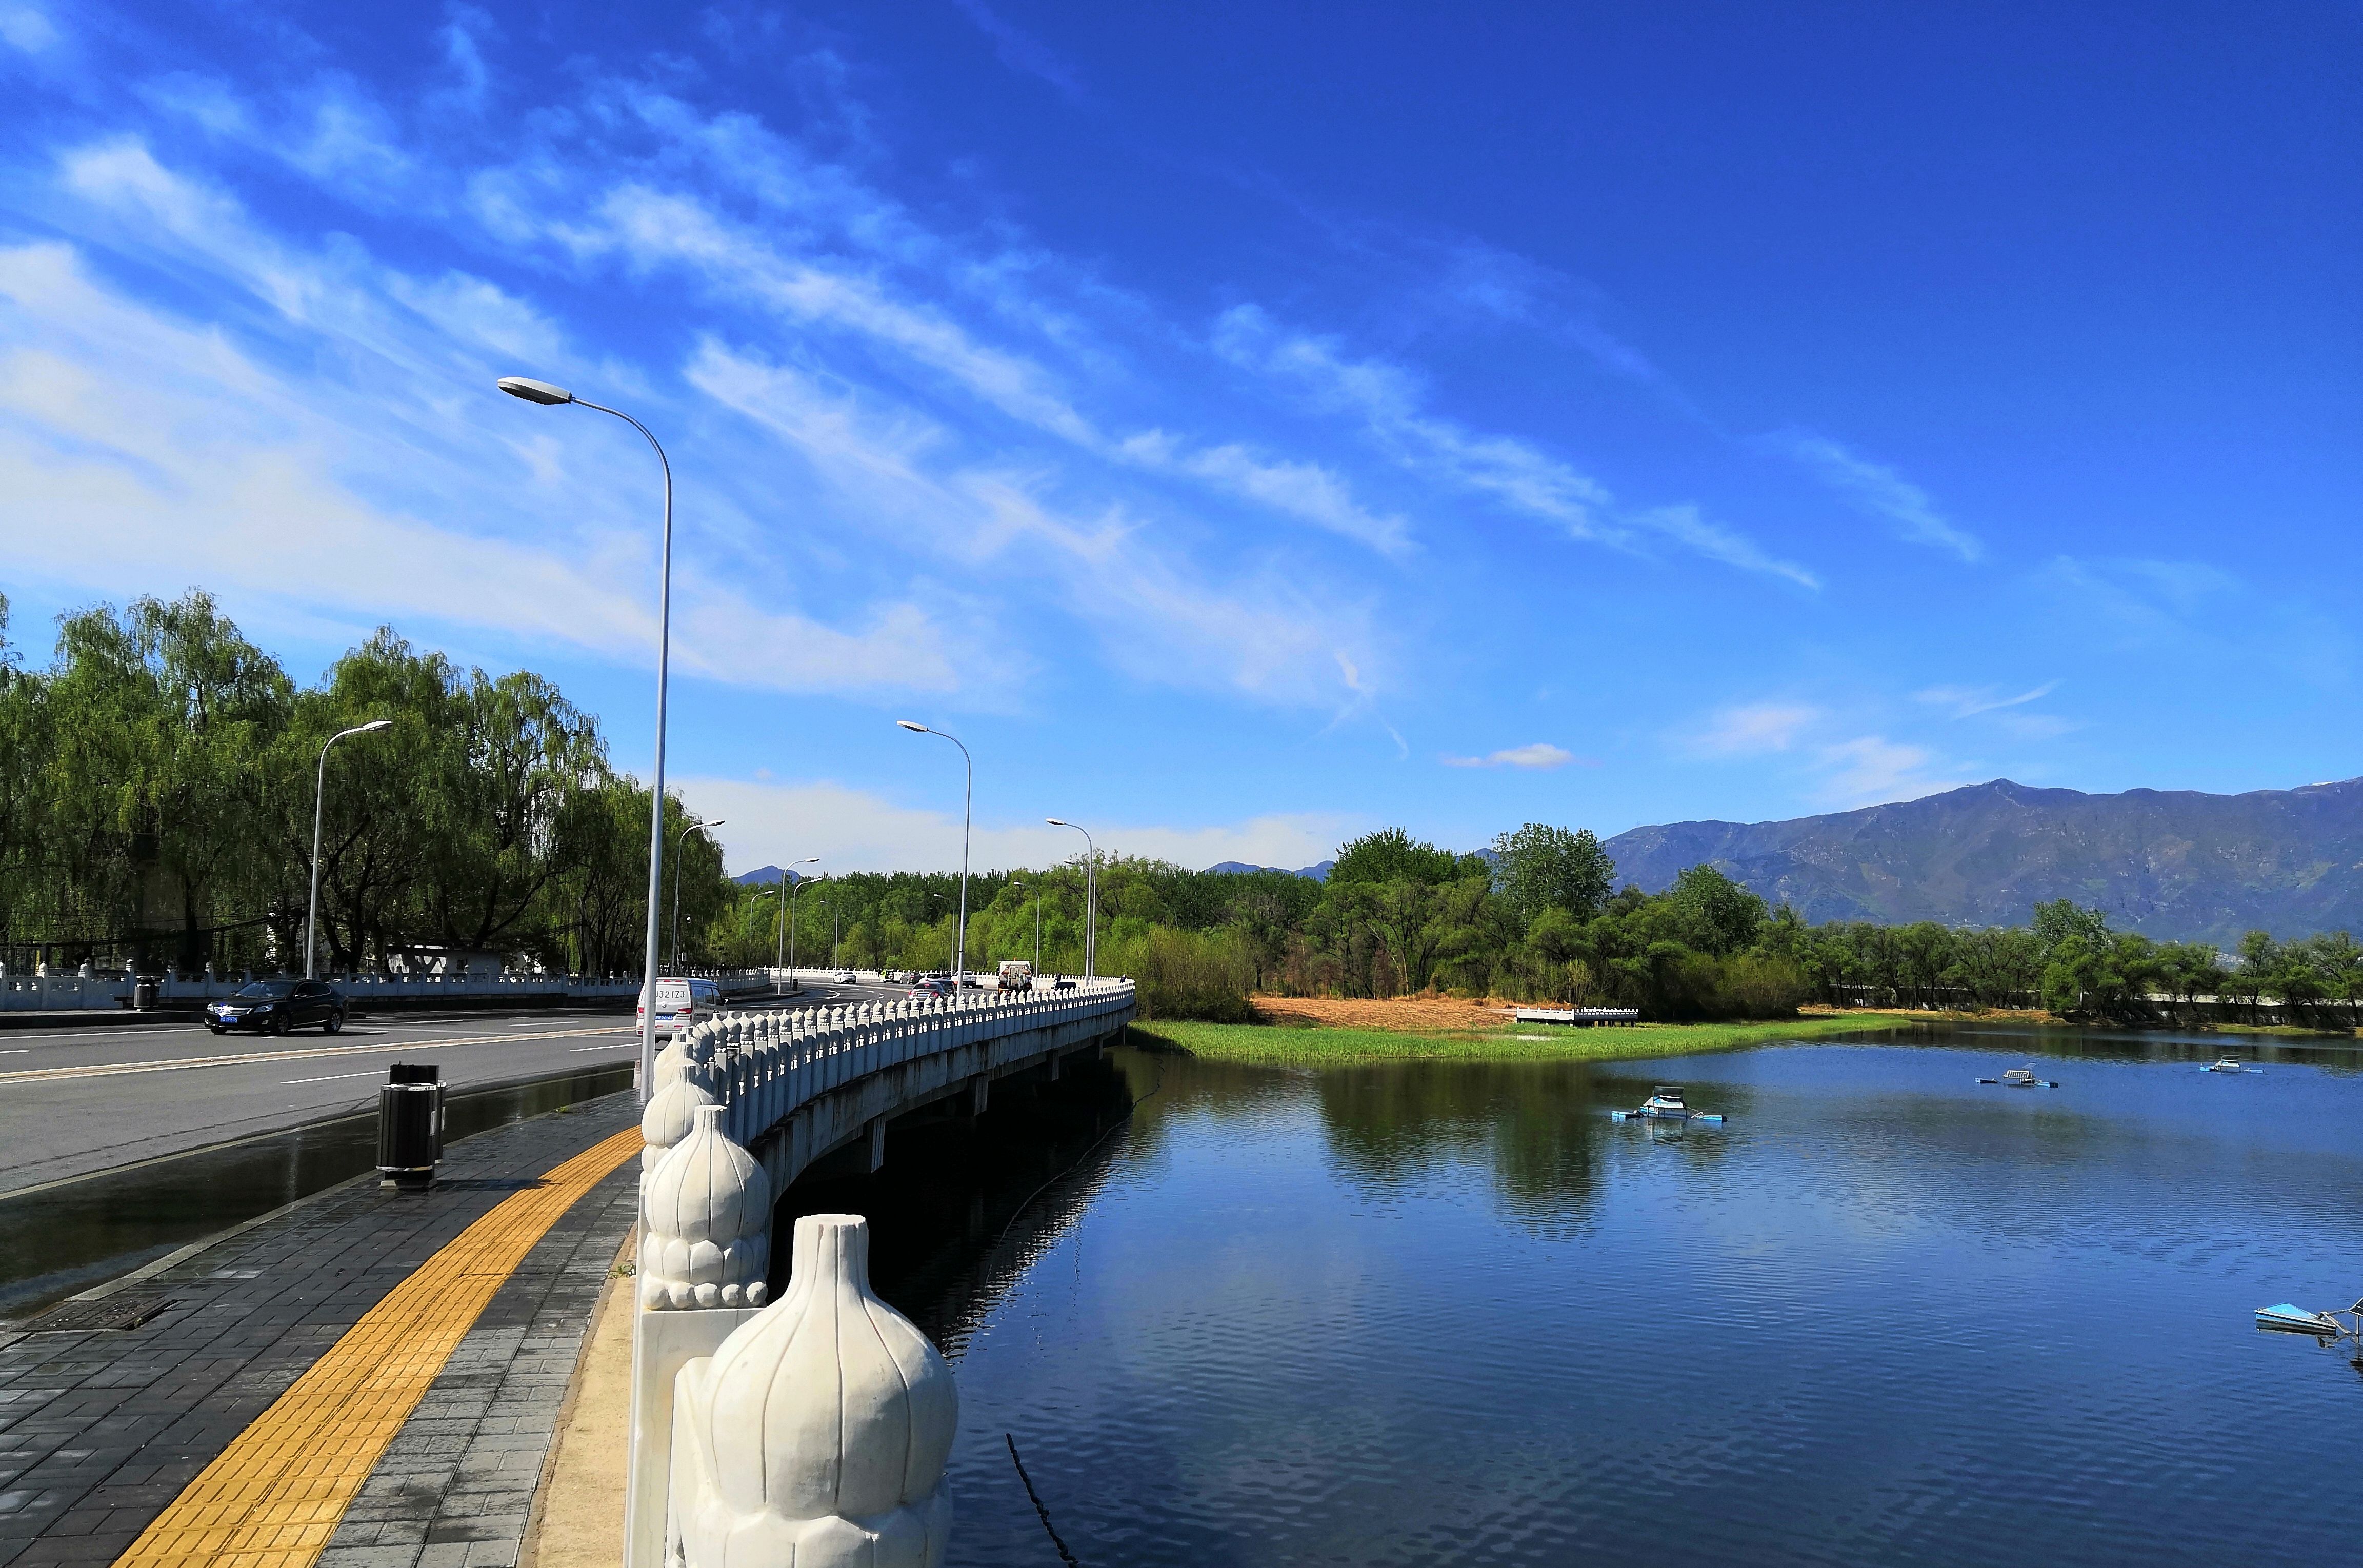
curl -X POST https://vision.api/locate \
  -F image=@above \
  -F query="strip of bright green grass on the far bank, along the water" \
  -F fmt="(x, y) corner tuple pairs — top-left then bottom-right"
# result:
(1132, 1013), (1919, 1068)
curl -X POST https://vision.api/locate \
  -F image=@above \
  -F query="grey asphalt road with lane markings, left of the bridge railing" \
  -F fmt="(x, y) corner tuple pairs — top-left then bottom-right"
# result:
(0, 982), (903, 1197)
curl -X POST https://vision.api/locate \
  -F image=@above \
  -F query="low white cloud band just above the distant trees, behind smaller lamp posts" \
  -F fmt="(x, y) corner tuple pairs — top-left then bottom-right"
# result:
(678, 777), (1356, 874)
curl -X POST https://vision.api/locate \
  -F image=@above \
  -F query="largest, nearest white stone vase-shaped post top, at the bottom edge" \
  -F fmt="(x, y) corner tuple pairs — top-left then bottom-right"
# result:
(666, 1214), (959, 1568)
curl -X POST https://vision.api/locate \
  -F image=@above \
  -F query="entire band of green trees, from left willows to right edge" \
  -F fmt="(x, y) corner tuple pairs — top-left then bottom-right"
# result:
(0, 590), (2363, 1030)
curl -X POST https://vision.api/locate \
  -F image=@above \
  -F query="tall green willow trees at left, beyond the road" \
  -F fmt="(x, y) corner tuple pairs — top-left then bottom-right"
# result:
(0, 590), (735, 975)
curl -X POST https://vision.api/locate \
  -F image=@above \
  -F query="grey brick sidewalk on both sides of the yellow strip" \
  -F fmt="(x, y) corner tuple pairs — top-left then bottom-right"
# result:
(0, 1093), (638, 1568)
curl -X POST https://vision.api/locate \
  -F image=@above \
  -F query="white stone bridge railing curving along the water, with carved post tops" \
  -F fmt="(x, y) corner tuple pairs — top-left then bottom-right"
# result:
(624, 980), (1134, 1568)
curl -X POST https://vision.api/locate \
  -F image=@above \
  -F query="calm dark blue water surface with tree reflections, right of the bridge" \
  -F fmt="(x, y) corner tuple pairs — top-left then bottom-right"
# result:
(952, 1032), (2363, 1568)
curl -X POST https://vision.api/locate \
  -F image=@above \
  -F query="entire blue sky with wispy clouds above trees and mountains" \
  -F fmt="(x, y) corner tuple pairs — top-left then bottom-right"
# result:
(0, 0), (2363, 869)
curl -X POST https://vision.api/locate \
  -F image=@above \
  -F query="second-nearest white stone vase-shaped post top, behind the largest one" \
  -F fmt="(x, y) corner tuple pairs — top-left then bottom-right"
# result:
(640, 1100), (770, 1311)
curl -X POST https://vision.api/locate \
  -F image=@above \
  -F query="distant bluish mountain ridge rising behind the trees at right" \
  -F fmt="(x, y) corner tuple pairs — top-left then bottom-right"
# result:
(1605, 779), (2363, 944)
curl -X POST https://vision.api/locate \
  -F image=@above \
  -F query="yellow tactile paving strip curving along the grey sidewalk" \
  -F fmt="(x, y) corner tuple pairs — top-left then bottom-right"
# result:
(116, 1127), (640, 1568)
